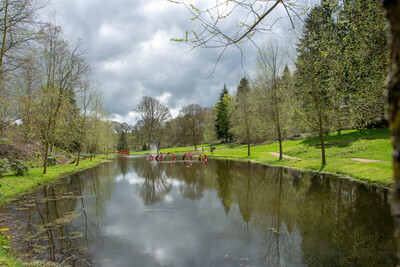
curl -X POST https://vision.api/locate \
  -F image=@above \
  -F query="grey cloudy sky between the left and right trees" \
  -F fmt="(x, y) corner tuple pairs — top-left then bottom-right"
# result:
(45, 0), (300, 125)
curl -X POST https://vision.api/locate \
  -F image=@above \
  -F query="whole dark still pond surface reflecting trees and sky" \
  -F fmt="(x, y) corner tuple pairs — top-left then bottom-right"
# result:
(0, 157), (396, 266)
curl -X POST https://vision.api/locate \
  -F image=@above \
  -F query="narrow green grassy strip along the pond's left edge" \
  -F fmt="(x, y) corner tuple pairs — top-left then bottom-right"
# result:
(0, 155), (113, 266)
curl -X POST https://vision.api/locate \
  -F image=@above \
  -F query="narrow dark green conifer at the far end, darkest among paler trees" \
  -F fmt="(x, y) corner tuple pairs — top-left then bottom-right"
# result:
(215, 84), (232, 142)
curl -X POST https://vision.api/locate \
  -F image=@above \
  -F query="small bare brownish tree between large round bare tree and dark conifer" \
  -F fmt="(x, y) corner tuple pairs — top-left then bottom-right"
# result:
(180, 104), (205, 150)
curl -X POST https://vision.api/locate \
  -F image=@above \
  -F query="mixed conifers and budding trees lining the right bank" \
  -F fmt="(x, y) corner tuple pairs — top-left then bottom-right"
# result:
(132, 0), (388, 164)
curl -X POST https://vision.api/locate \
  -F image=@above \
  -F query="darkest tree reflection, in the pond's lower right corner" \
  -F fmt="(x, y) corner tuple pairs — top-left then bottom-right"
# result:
(298, 175), (395, 266)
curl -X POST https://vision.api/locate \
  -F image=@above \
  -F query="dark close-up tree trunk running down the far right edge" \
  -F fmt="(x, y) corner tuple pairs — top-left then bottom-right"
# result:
(383, 0), (400, 258)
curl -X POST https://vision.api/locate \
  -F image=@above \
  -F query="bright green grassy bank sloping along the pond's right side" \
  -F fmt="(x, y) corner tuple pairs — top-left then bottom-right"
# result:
(139, 129), (392, 187)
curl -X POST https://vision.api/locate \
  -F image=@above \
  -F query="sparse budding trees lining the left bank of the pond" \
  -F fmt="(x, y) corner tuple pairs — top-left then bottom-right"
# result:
(0, 0), (115, 173)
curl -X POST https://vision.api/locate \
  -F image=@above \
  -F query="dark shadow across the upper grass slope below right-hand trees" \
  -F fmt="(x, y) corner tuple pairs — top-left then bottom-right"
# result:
(300, 129), (390, 148)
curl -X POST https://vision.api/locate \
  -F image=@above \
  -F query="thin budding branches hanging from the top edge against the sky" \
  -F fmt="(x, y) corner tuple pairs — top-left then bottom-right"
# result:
(169, 0), (297, 69)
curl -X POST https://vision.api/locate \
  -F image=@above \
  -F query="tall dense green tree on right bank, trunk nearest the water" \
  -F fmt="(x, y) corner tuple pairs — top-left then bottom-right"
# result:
(295, 0), (334, 165)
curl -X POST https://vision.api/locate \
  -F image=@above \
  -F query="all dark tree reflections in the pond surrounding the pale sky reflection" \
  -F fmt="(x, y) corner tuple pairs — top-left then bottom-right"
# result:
(3, 159), (395, 266)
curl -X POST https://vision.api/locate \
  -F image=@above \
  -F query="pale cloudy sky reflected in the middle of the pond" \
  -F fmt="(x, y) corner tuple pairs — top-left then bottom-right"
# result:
(82, 165), (301, 266)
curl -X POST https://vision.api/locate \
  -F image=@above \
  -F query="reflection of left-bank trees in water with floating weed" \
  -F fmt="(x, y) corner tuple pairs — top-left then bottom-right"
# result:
(1, 161), (116, 266)
